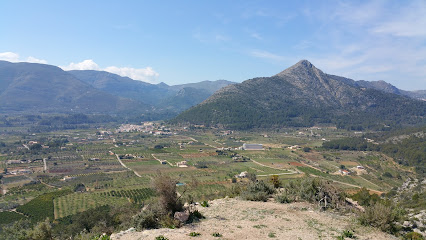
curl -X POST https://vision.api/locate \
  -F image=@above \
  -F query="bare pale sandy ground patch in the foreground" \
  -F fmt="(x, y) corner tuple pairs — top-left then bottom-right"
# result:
(112, 198), (397, 240)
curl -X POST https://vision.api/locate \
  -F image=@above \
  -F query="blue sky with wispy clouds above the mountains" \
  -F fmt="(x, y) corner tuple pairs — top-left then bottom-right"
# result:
(0, 0), (426, 90)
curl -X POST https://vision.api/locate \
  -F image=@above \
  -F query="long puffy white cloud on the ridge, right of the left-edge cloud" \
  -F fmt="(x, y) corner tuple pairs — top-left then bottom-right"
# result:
(60, 59), (160, 83)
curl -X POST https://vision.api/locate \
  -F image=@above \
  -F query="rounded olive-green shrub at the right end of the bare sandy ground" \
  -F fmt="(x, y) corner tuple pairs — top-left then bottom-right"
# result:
(359, 202), (401, 233)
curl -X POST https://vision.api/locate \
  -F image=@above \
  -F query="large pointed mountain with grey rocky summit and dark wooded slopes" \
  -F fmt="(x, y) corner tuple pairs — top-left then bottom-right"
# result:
(171, 60), (426, 129)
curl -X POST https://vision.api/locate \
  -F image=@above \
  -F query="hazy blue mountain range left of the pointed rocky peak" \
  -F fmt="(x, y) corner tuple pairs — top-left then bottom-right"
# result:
(0, 61), (232, 116)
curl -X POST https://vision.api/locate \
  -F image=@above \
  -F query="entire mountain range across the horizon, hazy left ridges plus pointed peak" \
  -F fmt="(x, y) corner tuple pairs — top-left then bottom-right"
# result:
(0, 61), (426, 128)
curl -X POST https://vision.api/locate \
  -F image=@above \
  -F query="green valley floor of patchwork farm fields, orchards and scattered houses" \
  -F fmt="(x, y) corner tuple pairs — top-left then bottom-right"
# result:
(0, 124), (420, 236)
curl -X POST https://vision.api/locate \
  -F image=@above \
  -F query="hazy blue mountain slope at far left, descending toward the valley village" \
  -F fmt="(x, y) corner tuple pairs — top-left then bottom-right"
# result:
(0, 61), (147, 113)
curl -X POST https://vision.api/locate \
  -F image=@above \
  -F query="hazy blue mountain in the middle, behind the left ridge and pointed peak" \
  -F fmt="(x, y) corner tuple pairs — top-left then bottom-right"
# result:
(69, 70), (233, 112)
